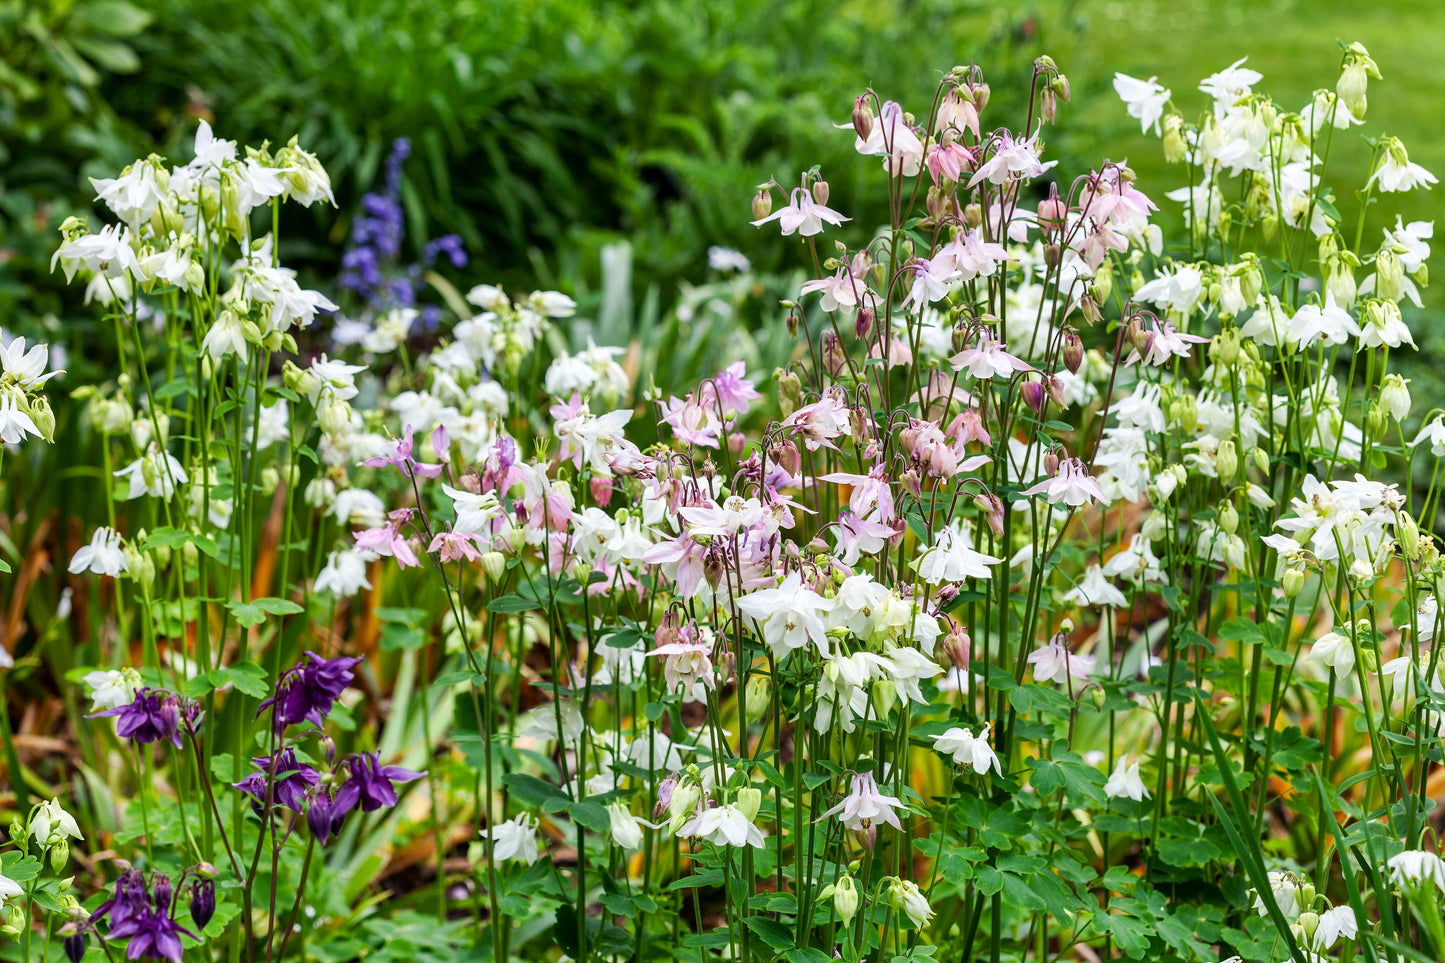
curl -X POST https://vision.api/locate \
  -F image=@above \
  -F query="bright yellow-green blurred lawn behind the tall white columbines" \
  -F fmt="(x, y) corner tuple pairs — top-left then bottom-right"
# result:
(1056, 0), (1445, 263)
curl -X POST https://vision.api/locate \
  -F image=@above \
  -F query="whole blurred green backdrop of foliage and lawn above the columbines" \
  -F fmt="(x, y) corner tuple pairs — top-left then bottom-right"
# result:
(0, 0), (1445, 353)
